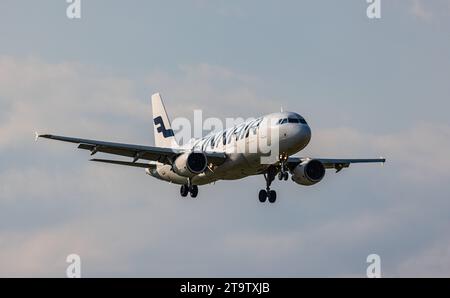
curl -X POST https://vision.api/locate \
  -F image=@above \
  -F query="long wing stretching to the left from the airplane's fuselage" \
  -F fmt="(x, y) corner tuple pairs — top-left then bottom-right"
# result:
(36, 134), (226, 165)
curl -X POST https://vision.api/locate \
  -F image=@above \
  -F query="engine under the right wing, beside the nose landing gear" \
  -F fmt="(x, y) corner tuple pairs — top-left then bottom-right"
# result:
(291, 159), (325, 186)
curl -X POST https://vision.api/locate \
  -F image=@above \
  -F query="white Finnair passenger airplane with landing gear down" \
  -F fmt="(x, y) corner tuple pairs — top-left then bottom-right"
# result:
(36, 93), (386, 203)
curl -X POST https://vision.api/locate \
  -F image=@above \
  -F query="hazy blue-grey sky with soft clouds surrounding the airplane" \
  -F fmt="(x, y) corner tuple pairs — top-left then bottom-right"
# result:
(0, 0), (450, 277)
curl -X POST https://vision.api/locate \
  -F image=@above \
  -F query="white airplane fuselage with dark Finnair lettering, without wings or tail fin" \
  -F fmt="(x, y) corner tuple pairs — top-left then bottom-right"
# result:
(147, 112), (311, 185)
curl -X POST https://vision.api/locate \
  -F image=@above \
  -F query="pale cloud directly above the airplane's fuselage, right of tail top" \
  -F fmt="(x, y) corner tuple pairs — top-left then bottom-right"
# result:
(146, 63), (279, 117)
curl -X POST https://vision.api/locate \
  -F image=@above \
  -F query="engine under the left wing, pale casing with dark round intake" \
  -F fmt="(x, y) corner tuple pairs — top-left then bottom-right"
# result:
(172, 152), (208, 177)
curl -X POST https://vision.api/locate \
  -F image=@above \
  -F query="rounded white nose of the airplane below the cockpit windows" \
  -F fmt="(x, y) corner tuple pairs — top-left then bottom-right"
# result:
(280, 124), (311, 154)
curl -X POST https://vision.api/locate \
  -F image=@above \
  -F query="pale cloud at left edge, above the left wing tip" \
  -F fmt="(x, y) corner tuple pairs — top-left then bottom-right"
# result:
(0, 56), (150, 148)
